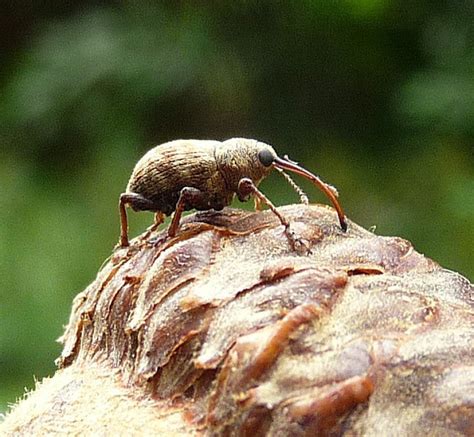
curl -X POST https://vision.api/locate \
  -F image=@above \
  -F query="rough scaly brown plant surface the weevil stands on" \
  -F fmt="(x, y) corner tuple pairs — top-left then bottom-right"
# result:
(0, 205), (474, 436)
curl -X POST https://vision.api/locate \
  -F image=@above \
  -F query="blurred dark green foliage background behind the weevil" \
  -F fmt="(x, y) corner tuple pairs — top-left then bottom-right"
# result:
(0, 0), (474, 411)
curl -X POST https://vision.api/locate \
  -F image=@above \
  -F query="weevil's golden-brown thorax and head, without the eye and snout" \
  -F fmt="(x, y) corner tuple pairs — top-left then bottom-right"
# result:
(215, 138), (277, 192)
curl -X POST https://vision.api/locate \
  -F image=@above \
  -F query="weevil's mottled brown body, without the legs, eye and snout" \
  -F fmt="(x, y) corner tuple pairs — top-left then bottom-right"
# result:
(126, 138), (276, 215)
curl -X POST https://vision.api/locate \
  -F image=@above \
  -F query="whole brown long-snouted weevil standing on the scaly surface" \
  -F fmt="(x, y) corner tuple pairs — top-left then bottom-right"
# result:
(119, 138), (347, 247)
